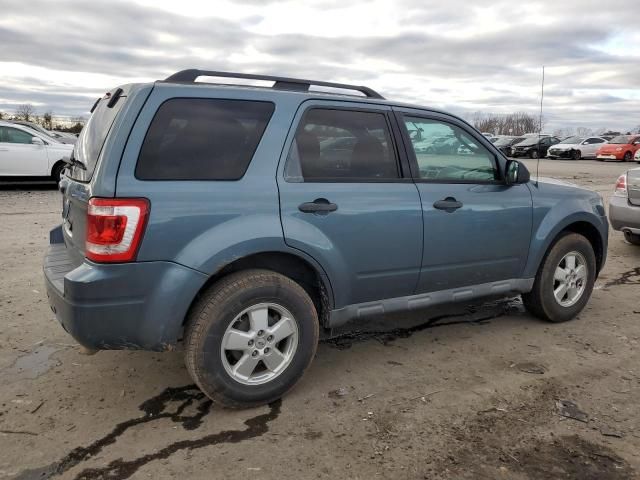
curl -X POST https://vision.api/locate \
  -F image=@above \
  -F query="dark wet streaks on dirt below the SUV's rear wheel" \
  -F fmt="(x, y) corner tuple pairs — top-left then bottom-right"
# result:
(16, 385), (281, 480)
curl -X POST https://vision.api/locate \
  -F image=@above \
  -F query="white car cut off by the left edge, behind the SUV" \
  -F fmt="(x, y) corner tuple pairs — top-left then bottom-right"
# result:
(0, 121), (73, 182)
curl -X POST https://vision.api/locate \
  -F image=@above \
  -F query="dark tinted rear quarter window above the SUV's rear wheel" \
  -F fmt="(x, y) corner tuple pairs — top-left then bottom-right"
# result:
(136, 98), (274, 180)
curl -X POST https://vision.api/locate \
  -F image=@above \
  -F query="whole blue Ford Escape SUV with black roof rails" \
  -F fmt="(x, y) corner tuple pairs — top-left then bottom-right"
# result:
(44, 70), (608, 407)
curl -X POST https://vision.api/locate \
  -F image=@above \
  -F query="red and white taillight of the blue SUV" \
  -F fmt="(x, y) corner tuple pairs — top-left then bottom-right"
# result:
(85, 198), (149, 263)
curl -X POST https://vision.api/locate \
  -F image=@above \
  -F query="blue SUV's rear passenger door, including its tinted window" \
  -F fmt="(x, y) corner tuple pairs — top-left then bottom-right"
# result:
(278, 101), (423, 308)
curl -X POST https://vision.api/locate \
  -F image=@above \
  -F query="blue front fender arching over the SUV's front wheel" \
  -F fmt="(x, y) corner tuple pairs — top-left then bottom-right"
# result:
(523, 196), (608, 278)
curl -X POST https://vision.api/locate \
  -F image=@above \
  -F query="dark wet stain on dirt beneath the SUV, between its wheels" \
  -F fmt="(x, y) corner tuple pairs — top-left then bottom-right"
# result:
(320, 297), (524, 350)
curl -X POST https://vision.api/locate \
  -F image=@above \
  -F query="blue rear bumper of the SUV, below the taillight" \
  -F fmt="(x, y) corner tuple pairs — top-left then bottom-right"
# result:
(44, 227), (207, 351)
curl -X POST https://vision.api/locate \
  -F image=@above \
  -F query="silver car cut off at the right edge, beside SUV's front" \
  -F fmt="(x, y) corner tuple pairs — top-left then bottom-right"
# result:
(609, 168), (640, 245)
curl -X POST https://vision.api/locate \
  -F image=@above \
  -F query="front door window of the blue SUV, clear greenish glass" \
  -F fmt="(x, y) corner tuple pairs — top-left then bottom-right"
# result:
(404, 117), (499, 182)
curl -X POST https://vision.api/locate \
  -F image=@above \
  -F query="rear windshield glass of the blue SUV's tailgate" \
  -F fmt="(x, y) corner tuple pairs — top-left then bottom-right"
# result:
(70, 89), (126, 182)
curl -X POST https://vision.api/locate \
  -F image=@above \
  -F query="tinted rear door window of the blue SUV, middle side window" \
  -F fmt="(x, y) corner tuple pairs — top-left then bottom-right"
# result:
(285, 108), (399, 182)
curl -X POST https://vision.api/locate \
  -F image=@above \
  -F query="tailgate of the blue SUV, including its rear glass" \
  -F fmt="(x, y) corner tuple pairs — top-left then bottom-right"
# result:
(60, 85), (130, 265)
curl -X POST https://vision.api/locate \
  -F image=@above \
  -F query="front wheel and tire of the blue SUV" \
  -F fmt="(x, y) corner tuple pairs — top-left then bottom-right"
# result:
(522, 233), (596, 322)
